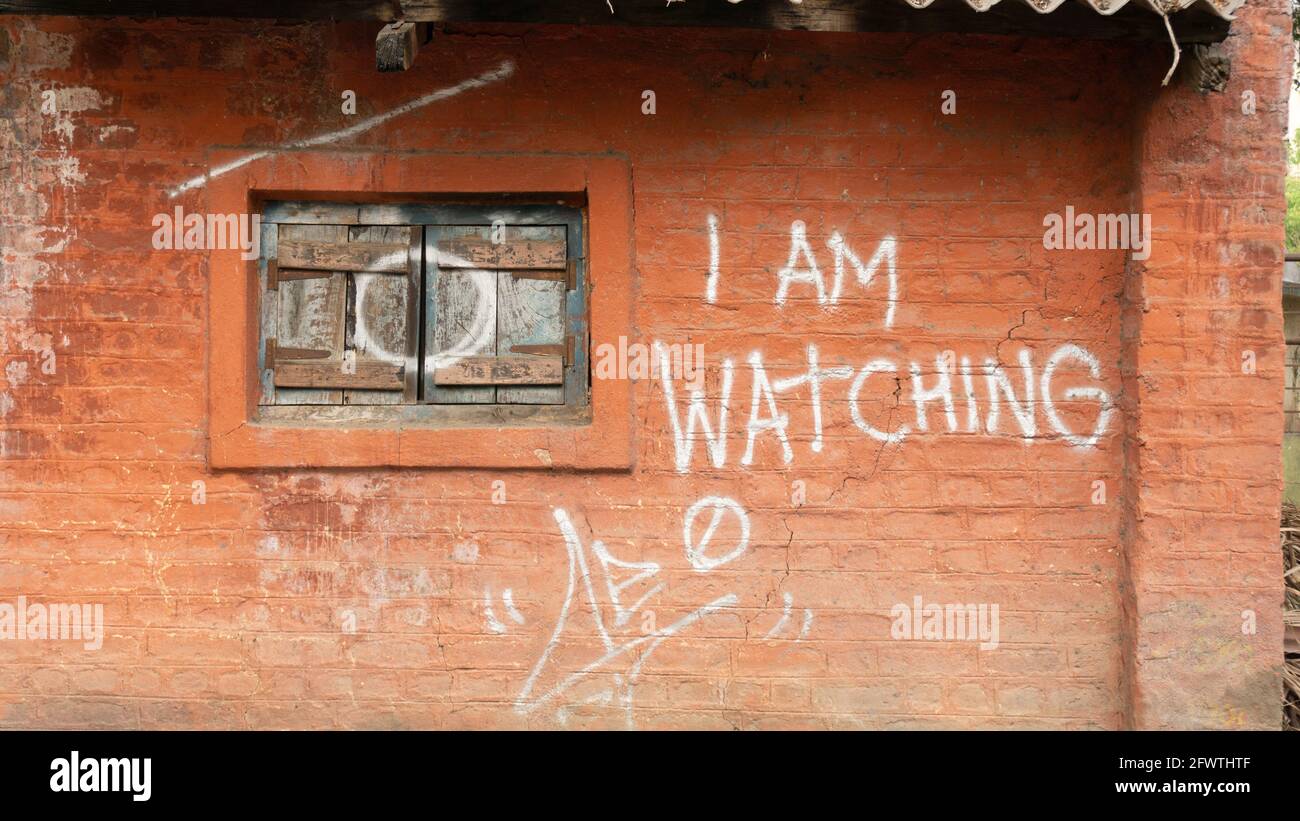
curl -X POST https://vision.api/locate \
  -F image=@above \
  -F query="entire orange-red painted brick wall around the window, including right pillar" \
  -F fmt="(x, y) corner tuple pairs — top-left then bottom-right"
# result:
(0, 3), (1288, 727)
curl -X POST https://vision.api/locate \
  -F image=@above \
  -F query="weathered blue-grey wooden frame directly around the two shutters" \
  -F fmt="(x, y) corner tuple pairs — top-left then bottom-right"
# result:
(255, 202), (592, 427)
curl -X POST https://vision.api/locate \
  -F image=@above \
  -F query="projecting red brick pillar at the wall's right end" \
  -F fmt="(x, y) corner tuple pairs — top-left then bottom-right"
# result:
(1122, 3), (1295, 729)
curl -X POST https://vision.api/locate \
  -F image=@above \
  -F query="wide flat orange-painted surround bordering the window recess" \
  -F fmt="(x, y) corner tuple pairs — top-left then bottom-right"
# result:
(205, 147), (637, 472)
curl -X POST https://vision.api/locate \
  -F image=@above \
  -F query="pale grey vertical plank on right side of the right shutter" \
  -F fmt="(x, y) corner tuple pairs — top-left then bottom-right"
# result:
(497, 272), (566, 405)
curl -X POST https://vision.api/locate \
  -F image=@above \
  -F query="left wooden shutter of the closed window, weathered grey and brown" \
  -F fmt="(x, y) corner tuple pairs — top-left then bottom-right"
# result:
(260, 225), (423, 404)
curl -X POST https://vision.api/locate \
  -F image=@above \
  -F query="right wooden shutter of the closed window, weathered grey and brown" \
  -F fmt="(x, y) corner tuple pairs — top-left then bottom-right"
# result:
(425, 225), (576, 404)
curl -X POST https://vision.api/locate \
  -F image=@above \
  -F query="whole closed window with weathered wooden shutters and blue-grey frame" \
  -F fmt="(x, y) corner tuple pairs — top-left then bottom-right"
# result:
(259, 201), (589, 423)
